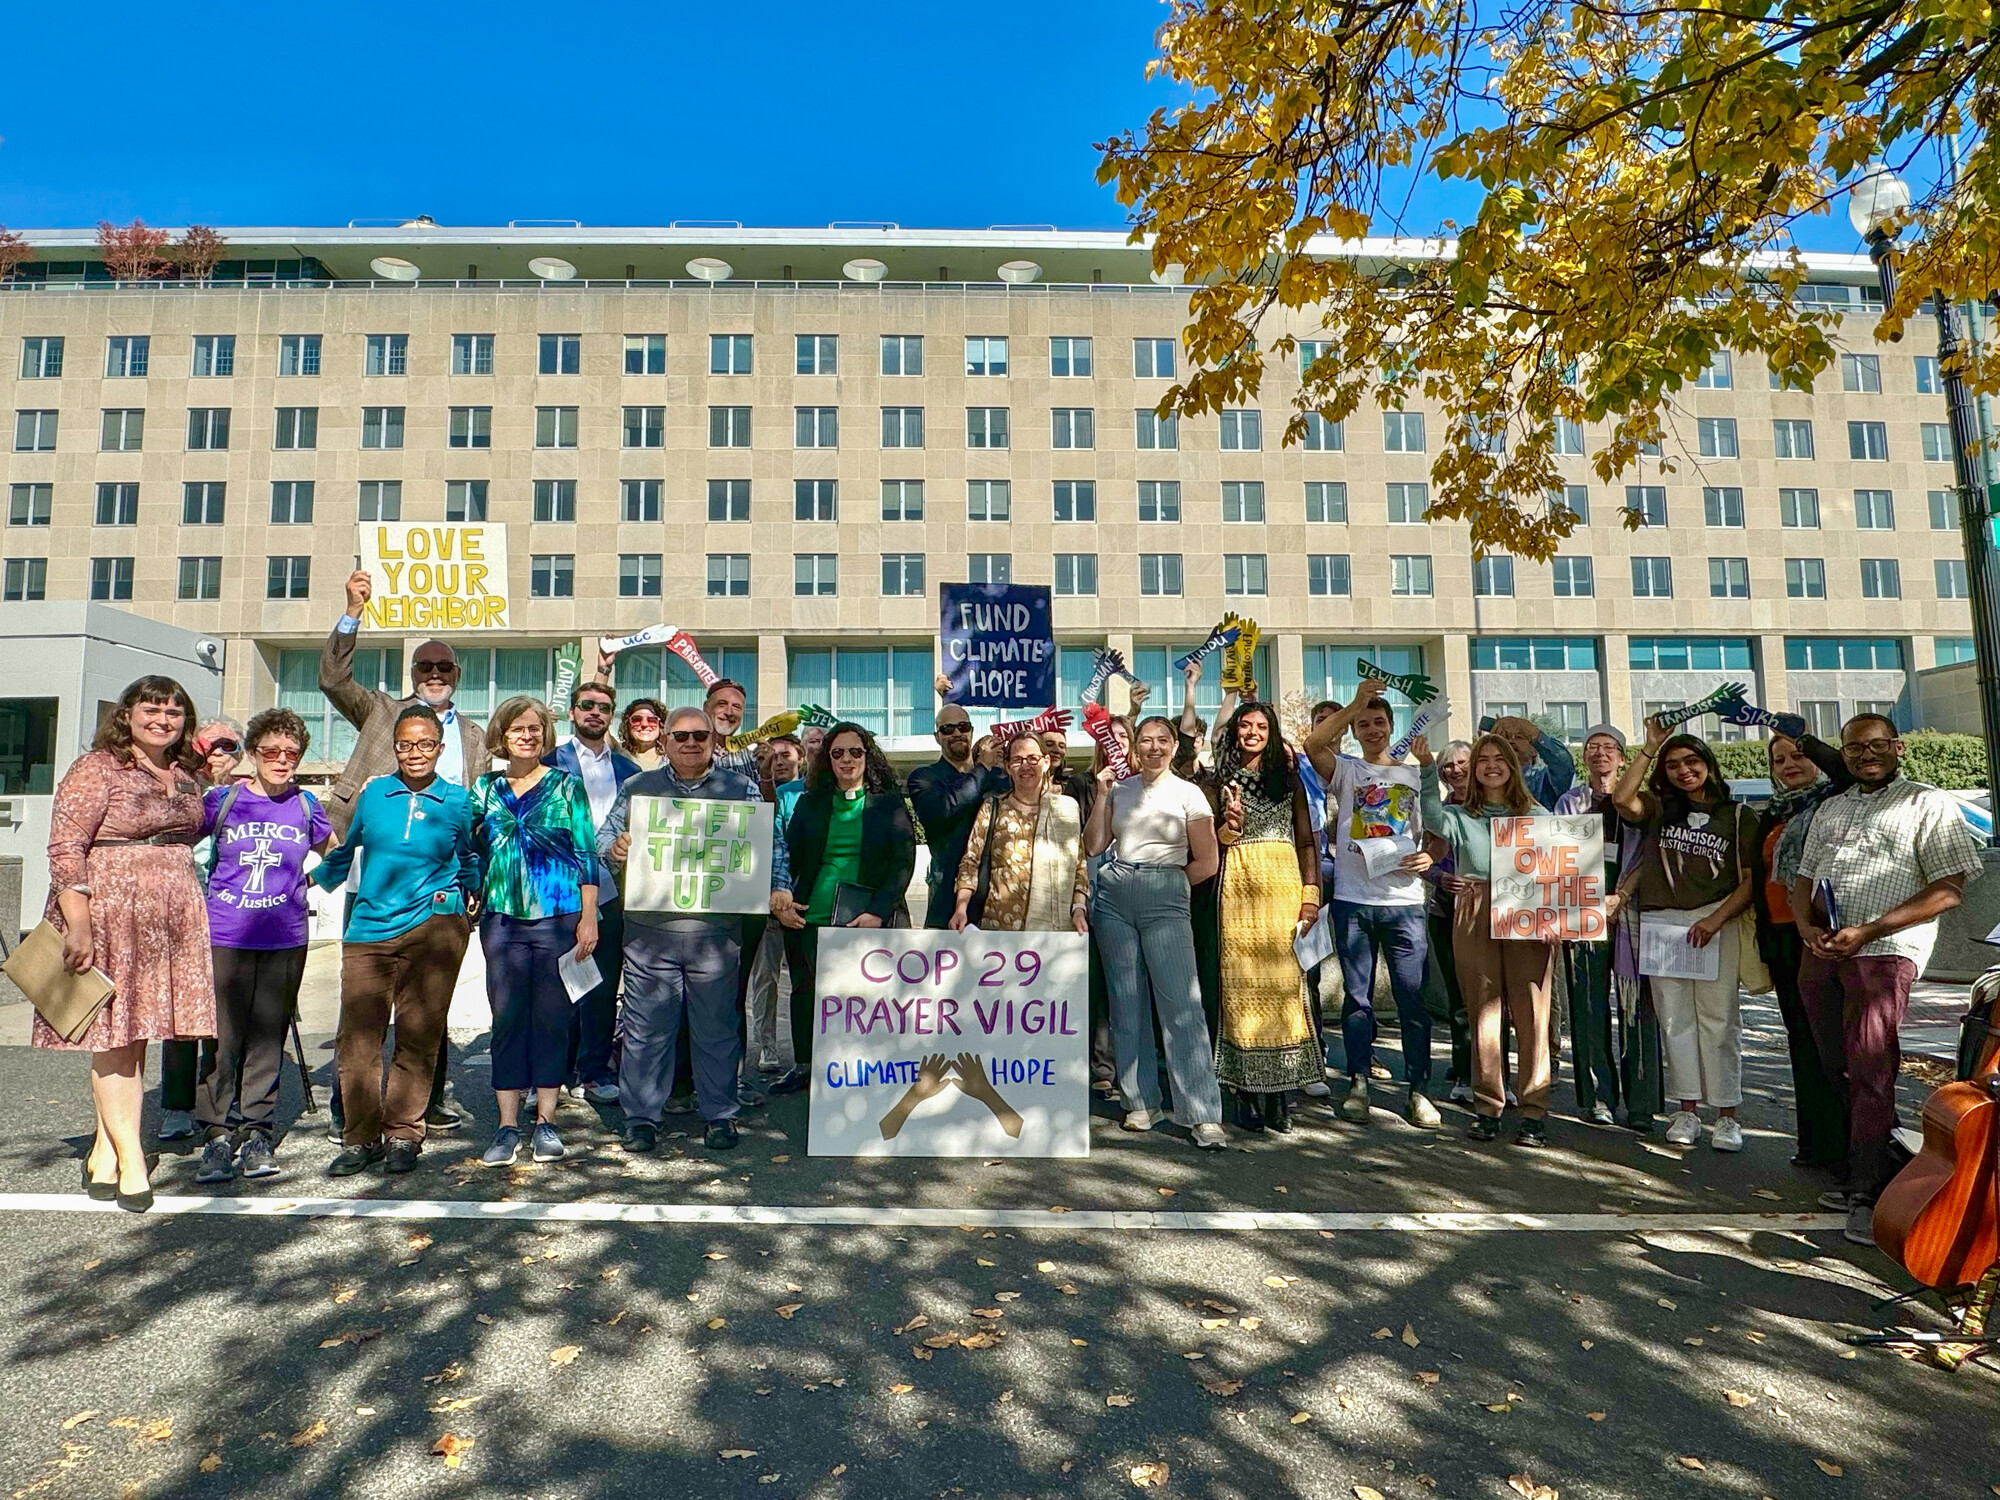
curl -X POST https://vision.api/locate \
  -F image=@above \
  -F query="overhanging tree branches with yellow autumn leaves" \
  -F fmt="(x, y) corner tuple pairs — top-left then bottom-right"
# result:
(1100, 0), (2000, 558)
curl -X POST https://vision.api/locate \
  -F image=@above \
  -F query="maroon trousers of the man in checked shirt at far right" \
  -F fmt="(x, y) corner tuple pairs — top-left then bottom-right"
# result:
(1798, 952), (1916, 1200)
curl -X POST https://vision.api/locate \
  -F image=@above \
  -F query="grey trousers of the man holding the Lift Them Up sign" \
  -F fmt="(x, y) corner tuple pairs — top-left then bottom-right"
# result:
(618, 918), (742, 1126)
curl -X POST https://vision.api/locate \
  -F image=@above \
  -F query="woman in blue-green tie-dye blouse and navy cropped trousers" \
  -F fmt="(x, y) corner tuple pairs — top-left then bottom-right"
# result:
(472, 698), (598, 1166)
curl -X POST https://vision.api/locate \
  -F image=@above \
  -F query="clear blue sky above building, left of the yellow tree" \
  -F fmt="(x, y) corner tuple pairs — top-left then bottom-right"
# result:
(0, 0), (1166, 228)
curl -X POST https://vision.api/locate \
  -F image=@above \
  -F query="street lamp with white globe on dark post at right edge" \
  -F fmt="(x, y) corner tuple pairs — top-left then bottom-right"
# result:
(1848, 168), (2000, 848)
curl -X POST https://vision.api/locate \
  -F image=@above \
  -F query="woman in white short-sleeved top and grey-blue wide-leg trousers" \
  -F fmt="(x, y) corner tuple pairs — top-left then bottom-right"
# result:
(1084, 716), (1226, 1150)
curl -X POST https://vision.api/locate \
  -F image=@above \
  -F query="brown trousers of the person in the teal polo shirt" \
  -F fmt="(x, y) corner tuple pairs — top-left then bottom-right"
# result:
(338, 916), (472, 1146)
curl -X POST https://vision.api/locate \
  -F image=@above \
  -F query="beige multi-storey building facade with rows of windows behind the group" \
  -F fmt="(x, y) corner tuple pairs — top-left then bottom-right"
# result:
(0, 232), (1972, 776)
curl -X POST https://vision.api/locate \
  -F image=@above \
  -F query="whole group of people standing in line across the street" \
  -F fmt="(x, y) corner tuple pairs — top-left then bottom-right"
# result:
(36, 572), (1980, 1230)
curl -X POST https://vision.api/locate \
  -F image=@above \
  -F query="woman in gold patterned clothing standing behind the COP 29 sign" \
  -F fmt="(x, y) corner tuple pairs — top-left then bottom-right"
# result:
(950, 734), (1090, 932)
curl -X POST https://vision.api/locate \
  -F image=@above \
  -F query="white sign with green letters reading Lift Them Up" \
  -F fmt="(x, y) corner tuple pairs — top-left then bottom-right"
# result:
(624, 796), (772, 916)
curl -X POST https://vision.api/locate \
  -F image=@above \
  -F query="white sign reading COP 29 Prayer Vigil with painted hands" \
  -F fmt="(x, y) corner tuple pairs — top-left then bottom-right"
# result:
(806, 928), (1090, 1156)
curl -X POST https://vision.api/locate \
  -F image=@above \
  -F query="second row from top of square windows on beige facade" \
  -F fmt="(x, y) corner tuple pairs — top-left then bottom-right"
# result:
(14, 406), (1952, 464)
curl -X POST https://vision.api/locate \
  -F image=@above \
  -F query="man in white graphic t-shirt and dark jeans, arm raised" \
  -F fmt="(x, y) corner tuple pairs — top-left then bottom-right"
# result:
(1306, 678), (1440, 1130)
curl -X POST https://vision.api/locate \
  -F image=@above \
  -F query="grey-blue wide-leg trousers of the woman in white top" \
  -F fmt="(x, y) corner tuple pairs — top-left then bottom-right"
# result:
(1090, 860), (1222, 1126)
